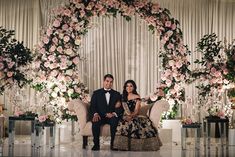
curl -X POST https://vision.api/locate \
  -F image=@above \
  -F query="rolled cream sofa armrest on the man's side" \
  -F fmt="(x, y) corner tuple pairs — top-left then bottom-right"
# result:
(68, 99), (88, 129)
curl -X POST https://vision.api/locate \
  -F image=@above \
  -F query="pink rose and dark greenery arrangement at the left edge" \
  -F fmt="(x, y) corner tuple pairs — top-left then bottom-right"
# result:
(0, 27), (32, 95)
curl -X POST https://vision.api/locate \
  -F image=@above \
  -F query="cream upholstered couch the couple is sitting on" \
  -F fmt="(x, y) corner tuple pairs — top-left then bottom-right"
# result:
(69, 99), (169, 148)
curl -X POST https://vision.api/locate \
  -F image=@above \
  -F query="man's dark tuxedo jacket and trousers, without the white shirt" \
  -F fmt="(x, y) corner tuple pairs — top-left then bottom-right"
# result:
(90, 88), (123, 147)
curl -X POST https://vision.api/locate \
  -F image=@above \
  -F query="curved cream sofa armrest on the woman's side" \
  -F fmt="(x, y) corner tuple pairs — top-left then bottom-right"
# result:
(149, 100), (170, 127)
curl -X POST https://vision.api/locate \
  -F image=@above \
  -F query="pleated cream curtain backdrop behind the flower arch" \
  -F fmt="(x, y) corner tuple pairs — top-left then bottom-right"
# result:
(0, 0), (235, 113)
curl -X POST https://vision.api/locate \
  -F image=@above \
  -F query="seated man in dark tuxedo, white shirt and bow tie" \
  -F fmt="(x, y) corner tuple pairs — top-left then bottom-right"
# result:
(90, 74), (123, 150)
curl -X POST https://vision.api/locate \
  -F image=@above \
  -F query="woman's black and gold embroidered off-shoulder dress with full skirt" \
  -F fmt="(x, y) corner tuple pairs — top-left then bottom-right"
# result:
(113, 100), (162, 151)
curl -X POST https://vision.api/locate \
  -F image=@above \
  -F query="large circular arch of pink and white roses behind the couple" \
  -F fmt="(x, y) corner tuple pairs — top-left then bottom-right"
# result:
(34, 0), (189, 121)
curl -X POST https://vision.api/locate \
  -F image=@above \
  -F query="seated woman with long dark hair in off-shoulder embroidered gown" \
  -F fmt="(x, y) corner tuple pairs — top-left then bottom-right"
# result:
(113, 80), (162, 151)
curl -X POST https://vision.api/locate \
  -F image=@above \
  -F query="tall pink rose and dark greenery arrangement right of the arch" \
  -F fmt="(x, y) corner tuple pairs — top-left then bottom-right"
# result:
(191, 33), (229, 98)
